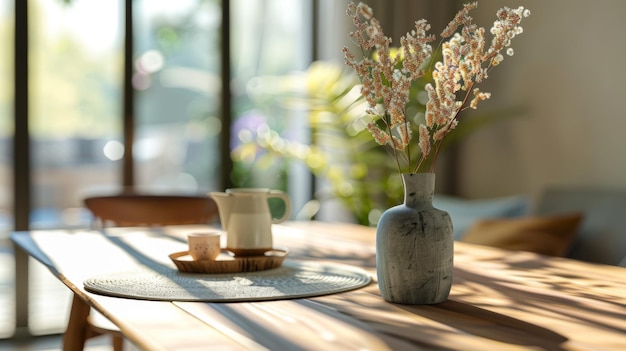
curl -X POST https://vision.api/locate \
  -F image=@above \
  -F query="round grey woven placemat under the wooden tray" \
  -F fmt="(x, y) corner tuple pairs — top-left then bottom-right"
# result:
(84, 260), (371, 302)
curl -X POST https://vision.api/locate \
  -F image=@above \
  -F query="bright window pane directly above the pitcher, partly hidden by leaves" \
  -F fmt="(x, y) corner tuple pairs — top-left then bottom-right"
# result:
(231, 0), (314, 211)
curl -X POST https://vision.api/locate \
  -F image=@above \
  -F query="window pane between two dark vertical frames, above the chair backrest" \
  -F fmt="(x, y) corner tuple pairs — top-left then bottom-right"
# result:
(133, 0), (222, 192)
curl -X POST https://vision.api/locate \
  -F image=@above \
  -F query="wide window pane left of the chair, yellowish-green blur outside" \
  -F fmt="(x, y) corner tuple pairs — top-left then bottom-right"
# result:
(29, 0), (123, 229)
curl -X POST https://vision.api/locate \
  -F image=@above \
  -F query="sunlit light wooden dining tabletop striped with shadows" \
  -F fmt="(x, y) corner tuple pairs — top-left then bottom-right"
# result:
(11, 221), (626, 351)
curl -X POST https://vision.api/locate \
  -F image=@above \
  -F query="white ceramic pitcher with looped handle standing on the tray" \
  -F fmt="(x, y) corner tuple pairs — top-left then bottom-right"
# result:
(209, 188), (291, 256)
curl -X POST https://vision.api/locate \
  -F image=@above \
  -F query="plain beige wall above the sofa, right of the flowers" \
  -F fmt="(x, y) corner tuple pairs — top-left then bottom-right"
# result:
(458, 0), (626, 204)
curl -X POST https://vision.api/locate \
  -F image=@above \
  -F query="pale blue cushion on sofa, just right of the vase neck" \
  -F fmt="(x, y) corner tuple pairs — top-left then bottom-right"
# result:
(433, 194), (530, 240)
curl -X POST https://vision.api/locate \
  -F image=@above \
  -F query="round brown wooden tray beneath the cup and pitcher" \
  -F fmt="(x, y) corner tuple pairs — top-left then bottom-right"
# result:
(169, 248), (289, 274)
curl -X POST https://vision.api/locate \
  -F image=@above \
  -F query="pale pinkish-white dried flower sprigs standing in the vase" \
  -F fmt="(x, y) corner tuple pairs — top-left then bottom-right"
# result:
(343, 2), (530, 172)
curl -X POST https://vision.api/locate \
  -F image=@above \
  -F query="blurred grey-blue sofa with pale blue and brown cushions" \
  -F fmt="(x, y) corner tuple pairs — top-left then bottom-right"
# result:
(433, 186), (626, 267)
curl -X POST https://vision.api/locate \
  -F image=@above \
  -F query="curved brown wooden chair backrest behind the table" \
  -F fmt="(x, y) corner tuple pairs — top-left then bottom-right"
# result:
(84, 194), (218, 227)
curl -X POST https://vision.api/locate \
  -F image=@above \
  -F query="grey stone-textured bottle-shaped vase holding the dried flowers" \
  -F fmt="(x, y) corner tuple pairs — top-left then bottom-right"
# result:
(376, 173), (454, 305)
